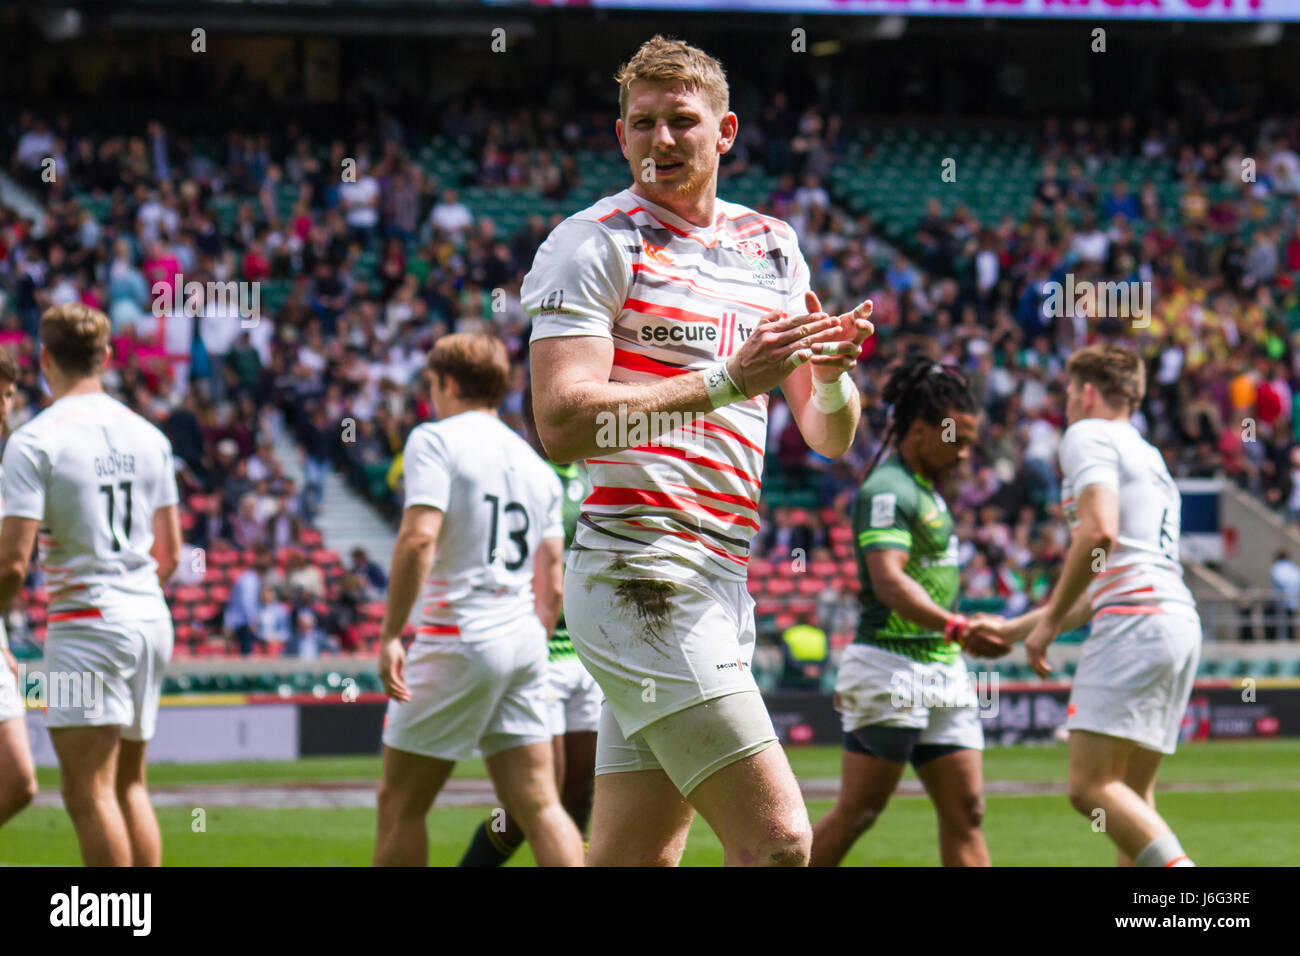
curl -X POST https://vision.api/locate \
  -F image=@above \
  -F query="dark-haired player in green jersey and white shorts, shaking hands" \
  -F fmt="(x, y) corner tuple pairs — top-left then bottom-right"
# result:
(810, 355), (1010, 866)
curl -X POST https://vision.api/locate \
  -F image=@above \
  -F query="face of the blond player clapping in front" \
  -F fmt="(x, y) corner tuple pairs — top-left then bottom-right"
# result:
(615, 81), (737, 208)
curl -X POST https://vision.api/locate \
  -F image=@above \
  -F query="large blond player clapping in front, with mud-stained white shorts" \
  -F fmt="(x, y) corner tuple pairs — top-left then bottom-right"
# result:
(521, 36), (871, 865)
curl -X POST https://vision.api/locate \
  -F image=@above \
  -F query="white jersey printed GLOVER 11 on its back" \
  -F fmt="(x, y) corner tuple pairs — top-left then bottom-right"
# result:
(4, 393), (179, 624)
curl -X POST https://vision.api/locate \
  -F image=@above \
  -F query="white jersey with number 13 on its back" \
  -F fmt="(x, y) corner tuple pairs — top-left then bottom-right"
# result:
(402, 411), (564, 640)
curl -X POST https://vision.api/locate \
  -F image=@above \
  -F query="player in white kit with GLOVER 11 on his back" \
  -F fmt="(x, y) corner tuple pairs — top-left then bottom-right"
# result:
(0, 303), (181, 866)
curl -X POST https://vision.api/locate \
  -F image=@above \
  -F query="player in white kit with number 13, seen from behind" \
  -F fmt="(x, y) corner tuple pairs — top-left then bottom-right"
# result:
(374, 334), (582, 866)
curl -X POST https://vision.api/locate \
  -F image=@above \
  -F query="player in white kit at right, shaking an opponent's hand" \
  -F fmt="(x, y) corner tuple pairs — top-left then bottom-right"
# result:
(984, 345), (1201, 866)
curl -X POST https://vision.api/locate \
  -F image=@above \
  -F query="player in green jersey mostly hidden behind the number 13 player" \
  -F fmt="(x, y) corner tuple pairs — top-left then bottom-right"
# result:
(460, 389), (603, 866)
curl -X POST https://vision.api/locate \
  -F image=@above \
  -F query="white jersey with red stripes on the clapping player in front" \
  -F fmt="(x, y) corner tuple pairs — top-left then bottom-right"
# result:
(520, 190), (809, 580)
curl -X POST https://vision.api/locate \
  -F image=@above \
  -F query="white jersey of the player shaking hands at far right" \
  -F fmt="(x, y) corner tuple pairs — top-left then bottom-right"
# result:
(1060, 419), (1196, 615)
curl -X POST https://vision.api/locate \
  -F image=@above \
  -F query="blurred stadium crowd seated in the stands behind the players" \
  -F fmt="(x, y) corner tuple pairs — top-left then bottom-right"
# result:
(0, 89), (1300, 656)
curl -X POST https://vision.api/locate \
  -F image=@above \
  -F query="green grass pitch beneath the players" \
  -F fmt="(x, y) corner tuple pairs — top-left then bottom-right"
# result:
(0, 740), (1300, 866)
